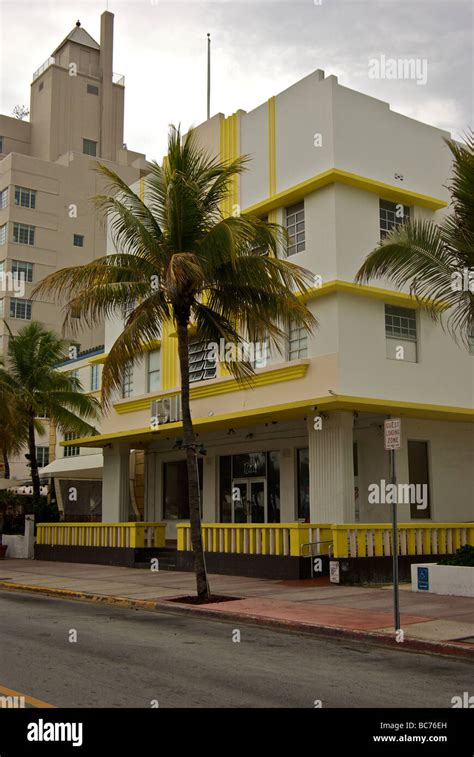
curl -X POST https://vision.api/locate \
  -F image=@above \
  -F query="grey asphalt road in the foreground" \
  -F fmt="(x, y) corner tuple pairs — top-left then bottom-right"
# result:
(0, 591), (474, 708)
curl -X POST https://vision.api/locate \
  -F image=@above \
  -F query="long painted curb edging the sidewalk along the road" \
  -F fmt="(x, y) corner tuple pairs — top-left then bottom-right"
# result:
(0, 581), (474, 662)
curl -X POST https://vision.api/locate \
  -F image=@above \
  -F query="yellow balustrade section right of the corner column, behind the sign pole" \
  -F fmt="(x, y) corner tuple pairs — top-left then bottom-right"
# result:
(331, 523), (474, 557)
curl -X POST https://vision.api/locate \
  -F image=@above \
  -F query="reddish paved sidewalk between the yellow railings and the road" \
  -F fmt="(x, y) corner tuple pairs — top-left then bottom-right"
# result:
(0, 559), (474, 659)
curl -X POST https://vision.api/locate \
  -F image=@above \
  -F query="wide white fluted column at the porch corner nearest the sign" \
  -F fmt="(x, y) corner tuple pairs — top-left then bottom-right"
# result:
(307, 413), (355, 523)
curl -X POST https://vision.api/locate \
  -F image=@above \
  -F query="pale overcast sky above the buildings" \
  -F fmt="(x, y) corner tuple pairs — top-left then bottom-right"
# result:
(0, 0), (474, 159)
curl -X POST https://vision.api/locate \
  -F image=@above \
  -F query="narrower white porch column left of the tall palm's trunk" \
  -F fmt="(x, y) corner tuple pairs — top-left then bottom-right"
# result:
(102, 444), (130, 523)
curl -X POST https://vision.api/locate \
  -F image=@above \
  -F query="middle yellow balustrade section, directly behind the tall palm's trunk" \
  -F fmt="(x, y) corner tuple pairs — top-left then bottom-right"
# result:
(176, 523), (331, 557)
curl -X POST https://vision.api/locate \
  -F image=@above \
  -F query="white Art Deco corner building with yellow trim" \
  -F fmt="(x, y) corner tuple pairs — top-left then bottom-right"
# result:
(53, 70), (474, 556)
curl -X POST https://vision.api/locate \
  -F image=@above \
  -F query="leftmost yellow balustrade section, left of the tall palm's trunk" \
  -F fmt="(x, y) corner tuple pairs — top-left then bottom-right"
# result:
(36, 522), (166, 547)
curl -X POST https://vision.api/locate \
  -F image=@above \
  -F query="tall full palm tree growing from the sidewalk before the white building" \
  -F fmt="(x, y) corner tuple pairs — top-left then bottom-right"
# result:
(35, 126), (315, 600)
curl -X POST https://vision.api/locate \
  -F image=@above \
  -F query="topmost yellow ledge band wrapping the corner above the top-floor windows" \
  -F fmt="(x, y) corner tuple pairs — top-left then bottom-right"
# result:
(242, 168), (448, 215)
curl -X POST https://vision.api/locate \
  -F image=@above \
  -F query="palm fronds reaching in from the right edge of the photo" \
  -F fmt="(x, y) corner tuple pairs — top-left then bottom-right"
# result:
(356, 130), (474, 341)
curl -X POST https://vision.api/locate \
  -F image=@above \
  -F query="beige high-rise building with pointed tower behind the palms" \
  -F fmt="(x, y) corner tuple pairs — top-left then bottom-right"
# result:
(0, 11), (146, 477)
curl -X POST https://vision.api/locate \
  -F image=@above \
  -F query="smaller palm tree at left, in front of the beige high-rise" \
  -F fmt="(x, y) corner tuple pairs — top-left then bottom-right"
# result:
(0, 321), (100, 497)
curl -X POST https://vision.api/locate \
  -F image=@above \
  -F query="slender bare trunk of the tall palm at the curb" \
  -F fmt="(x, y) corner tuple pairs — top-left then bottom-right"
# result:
(177, 315), (210, 600)
